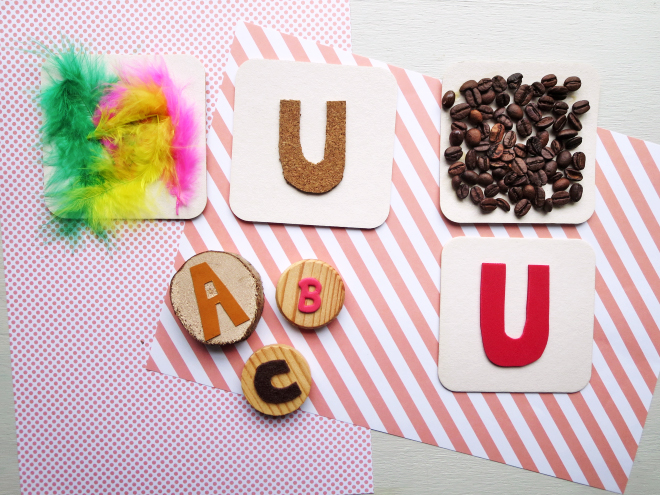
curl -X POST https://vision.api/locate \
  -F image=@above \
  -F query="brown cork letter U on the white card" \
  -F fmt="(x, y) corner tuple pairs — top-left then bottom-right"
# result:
(279, 100), (346, 194)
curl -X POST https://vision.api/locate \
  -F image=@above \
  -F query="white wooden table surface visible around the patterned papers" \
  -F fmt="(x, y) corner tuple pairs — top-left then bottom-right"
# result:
(0, 0), (660, 495)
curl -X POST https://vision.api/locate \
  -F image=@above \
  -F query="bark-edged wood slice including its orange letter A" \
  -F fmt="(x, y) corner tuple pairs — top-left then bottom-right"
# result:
(170, 251), (264, 345)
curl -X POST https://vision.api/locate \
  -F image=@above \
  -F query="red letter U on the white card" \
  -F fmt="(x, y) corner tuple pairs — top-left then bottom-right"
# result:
(481, 263), (550, 366)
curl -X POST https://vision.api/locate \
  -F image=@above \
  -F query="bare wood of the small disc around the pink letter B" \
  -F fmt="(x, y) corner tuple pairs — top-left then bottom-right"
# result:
(275, 260), (346, 330)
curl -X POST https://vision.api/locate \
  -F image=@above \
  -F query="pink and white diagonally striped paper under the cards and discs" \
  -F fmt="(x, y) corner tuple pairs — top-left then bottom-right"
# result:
(148, 24), (660, 492)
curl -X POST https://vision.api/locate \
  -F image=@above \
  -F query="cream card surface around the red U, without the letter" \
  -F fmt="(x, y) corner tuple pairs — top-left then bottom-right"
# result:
(438, 237), (596, 392)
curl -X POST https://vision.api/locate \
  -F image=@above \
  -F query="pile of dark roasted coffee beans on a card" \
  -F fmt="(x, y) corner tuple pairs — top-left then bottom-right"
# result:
(442, 73), (589, 217)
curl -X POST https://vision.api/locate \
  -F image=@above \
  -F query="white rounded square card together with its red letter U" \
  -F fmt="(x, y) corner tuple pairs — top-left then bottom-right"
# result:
(438, 237), (596, 393)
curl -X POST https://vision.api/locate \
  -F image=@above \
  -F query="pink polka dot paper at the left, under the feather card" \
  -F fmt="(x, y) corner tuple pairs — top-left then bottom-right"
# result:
(0, 0), (373, 494)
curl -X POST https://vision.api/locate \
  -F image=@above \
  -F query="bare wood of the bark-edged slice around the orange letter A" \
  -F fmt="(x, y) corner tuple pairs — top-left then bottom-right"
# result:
(170, 251), (264, 345)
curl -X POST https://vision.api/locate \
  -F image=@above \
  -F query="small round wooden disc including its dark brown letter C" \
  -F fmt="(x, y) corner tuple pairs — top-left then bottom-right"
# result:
(241, 344), (312, 416)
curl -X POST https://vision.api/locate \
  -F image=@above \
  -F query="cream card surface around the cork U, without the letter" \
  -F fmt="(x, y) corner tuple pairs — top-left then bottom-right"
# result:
(229, 60), (398, 228)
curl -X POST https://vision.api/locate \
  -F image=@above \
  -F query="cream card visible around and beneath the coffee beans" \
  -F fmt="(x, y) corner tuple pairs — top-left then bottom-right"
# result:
(440, 61), (600, 224)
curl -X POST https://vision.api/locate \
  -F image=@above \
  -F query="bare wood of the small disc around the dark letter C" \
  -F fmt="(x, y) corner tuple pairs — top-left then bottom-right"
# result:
(241, 344), (312, 416)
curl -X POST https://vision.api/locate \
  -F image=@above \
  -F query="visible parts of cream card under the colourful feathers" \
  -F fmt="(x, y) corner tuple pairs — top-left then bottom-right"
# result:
(41, 55), (207, 220)
